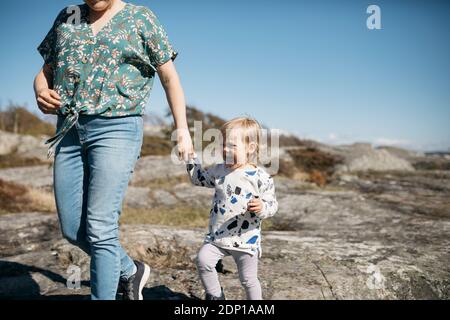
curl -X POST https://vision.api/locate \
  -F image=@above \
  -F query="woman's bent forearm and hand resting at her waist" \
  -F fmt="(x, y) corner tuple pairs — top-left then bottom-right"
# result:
(33, 64), (61, 114)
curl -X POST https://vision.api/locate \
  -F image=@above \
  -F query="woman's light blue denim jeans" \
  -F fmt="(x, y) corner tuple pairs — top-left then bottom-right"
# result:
(53, 115), (143, 300)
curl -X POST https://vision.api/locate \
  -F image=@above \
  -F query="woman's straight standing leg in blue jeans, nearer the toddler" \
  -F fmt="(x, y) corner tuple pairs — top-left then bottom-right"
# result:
(79, 116), (143, 300)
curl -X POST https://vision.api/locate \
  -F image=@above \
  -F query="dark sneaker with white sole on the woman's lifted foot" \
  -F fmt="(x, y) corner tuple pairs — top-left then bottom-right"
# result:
(119, 260), (150, 300)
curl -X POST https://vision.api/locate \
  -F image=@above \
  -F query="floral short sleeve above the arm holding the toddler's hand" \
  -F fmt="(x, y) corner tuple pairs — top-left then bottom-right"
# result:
(142, 7), (178, 69)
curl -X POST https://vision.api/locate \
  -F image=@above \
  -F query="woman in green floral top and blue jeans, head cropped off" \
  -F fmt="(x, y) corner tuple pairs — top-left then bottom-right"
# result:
(34, 0), (193, 300)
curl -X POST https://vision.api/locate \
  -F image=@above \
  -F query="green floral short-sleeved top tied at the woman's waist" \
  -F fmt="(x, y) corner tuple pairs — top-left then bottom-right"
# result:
(37, 3), (178, 157)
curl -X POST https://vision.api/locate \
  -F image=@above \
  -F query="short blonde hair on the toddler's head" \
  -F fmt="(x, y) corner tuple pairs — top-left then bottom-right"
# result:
(220, 117), (261, 165)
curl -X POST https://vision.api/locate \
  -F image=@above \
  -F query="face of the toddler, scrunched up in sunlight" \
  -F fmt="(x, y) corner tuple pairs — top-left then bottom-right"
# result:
(223, 128), (255, 166)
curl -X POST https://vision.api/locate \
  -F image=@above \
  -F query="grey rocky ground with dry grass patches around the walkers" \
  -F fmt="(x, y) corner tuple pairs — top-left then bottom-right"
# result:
(0, 126), (450, 299)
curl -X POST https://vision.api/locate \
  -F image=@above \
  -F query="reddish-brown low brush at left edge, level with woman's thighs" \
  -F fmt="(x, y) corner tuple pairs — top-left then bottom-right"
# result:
(0, 179), (56, 214)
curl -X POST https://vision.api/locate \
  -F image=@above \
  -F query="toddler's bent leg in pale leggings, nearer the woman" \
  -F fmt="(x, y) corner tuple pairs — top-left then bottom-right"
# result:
(197, 243), (226, 297)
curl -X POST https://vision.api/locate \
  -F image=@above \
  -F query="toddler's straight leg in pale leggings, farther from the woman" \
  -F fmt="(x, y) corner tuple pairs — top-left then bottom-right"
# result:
(231, 251), (262, 300)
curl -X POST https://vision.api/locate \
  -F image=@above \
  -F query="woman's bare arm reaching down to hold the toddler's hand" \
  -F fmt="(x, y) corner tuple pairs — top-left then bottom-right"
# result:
(157, 60), (194, 161)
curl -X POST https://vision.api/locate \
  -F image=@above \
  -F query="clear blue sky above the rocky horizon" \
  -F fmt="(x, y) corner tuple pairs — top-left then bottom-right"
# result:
(0, 0), (450, 150)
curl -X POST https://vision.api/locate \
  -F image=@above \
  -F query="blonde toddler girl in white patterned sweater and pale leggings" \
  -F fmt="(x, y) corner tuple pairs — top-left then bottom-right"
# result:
(187, 118), (278, 300)
